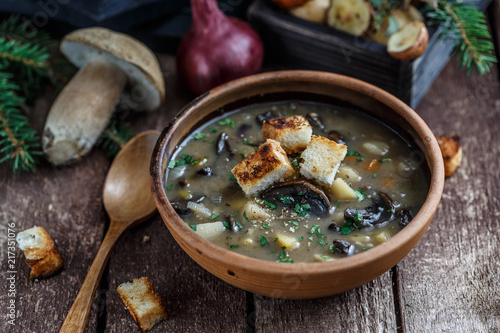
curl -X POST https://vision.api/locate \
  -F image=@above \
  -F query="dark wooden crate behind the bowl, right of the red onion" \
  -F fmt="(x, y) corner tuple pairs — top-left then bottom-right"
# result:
(248, 0), (491, 108)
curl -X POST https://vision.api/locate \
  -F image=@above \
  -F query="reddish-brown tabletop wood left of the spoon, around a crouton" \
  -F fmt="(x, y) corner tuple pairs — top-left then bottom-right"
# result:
(0, 146), (109, 332)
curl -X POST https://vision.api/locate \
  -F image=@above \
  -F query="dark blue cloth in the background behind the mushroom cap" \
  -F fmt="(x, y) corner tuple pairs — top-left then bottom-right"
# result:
(0, 0), (252, 53)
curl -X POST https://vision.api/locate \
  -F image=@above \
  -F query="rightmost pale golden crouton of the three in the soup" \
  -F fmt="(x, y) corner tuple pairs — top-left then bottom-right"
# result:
(300, 135), (347, 185)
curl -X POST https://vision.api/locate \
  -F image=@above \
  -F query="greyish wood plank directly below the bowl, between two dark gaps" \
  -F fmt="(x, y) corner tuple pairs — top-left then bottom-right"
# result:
(255, 272), (397, 333)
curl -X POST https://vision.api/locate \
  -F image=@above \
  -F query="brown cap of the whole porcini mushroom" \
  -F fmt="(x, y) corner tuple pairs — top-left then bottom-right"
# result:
(60, 27), (165, 111)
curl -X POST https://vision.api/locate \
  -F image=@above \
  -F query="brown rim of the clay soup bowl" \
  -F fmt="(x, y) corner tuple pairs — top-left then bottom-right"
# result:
(150, 70), (445, 275)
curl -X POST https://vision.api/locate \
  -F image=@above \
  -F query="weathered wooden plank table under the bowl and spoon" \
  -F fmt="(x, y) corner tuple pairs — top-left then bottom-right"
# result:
(0, 4), (500, 333)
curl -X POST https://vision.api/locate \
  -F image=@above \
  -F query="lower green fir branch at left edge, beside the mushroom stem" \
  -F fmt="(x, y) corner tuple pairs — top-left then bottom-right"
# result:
(0, 71), (41, 172)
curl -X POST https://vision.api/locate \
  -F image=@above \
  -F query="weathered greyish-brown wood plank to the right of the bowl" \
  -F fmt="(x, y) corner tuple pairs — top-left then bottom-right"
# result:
(399, 57), (500, 332)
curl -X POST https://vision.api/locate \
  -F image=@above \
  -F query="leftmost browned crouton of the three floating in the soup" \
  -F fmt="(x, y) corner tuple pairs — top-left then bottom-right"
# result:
(231, 139), (295, 196)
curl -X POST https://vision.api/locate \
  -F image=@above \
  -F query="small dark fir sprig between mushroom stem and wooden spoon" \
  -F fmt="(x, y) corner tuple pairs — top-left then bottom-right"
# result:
(97, 116), (134, 157)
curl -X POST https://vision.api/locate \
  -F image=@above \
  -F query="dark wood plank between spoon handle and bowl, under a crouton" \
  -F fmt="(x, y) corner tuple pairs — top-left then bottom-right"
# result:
(105, 215), (246, 333)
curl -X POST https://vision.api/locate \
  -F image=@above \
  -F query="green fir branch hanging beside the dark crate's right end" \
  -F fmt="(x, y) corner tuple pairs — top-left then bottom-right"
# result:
(426, 0), (497, 75)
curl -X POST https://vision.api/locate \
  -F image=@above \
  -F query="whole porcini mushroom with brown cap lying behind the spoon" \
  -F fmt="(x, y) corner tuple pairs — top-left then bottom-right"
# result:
(42, 28), (165, 165)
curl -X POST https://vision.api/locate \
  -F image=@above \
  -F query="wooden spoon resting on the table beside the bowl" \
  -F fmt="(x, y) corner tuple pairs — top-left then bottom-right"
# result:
(60, 131), (160, 333)
